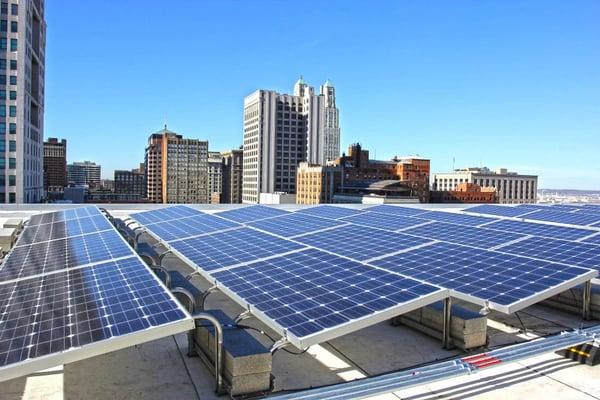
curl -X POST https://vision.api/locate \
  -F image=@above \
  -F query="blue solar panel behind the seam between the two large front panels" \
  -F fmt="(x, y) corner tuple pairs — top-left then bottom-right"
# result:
(294, 225), (430, 261)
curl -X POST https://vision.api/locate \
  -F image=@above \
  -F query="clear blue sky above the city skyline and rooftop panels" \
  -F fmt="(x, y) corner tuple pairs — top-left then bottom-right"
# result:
(45, 0), (600, 189)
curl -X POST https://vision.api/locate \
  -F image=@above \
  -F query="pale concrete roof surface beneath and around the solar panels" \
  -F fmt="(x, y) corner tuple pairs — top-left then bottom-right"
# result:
(0, 205), (600, 400)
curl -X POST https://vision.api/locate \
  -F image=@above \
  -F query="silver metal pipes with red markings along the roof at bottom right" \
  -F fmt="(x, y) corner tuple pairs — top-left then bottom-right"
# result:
(269, 325), (600, 400)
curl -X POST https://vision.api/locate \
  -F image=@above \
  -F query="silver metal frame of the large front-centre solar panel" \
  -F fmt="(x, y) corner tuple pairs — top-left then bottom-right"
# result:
(211, 248), (449, 350)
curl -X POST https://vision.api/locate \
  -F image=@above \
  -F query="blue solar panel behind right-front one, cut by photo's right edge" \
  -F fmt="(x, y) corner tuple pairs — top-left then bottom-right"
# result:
(500, 237), (600, 270)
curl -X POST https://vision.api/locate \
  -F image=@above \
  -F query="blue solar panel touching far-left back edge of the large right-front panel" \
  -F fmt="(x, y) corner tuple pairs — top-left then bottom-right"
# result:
(403, 222), (525, 249)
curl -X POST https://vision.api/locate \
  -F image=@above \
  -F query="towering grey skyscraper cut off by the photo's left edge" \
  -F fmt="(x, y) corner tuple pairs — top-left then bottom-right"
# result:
(0, 0), (46, 203)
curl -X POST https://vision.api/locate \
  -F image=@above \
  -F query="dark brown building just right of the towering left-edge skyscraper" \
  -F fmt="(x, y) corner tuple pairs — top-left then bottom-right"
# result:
(44, 138), (68, 193)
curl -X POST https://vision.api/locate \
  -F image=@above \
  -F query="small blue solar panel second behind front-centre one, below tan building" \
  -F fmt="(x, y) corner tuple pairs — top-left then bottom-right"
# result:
(248, 213), (345, 237)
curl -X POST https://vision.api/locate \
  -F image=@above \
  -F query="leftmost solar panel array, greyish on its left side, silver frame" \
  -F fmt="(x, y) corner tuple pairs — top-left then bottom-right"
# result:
(0, 207), (193, 381)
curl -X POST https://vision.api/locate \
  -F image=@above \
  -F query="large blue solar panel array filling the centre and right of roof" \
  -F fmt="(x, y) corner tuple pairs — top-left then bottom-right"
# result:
(133, 205), (600, 347)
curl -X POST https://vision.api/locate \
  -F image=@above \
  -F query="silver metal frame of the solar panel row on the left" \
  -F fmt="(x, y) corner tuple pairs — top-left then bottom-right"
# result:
(0, 206), (195, 382)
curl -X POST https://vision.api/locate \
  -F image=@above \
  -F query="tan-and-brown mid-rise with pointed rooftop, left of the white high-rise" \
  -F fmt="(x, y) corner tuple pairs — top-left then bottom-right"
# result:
(145, 126), (209, 203)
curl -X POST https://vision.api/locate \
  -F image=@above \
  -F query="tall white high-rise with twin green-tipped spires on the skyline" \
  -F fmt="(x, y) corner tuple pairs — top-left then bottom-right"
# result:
(243, 78), (340, 203)
